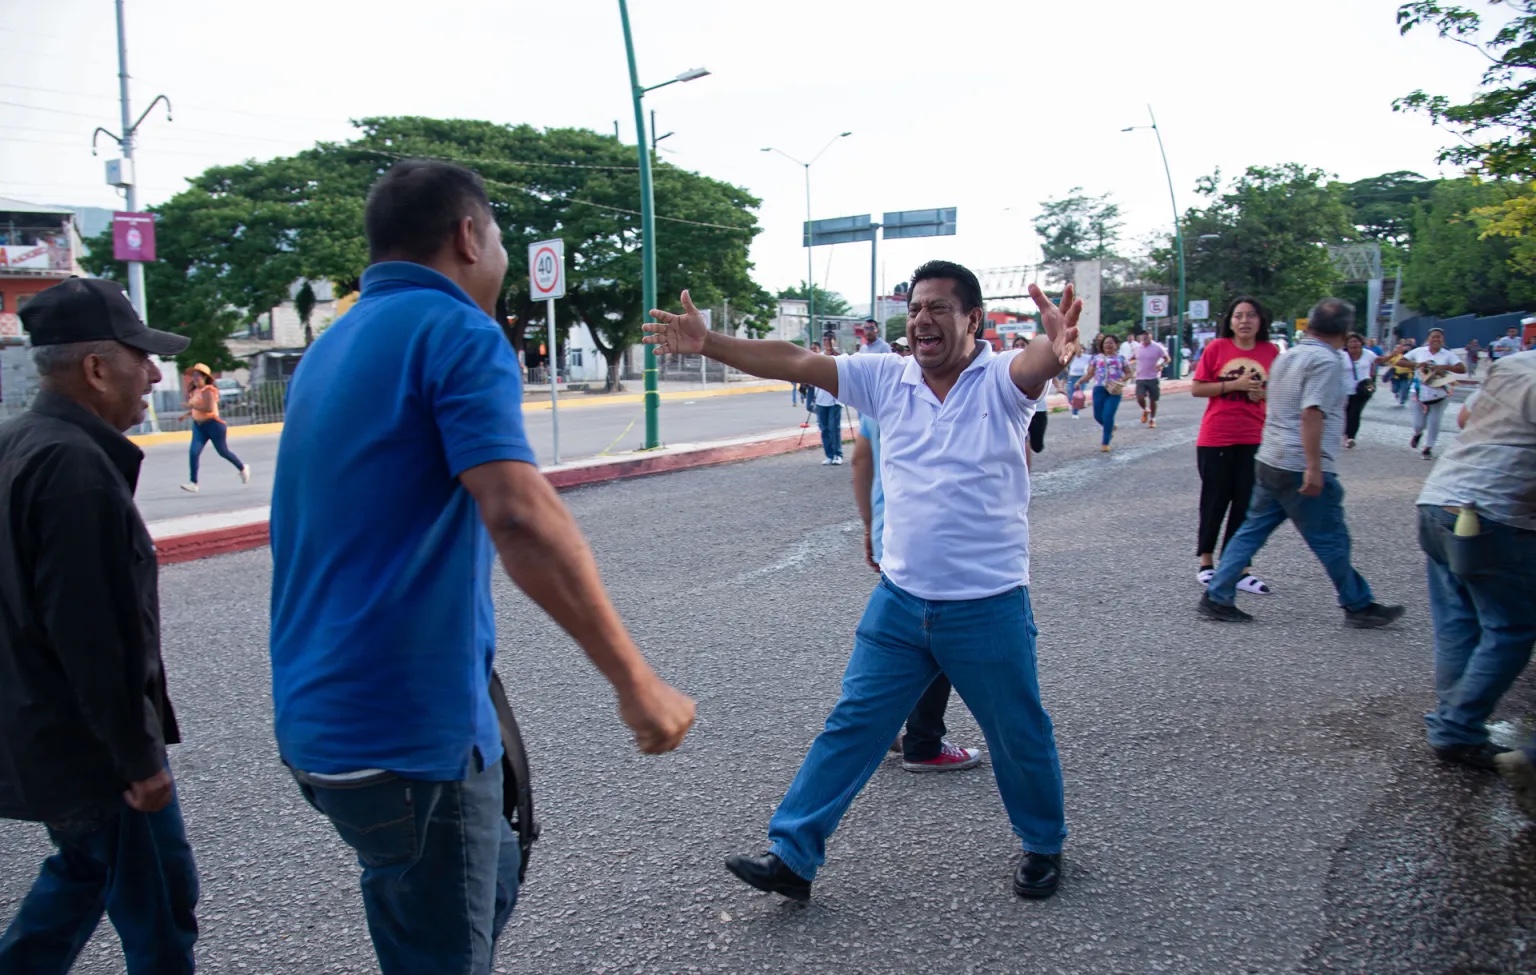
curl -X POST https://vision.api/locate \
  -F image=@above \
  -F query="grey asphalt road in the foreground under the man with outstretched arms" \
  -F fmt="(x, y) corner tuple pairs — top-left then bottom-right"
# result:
(0, 396), (1536, 975)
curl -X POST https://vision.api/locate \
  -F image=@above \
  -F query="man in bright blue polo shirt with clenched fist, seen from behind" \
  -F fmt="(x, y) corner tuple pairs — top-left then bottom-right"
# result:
(272, 161), (693, 975)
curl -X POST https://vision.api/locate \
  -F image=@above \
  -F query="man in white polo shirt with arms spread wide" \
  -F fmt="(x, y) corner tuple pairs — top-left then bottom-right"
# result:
(645, 261), (1083, 900)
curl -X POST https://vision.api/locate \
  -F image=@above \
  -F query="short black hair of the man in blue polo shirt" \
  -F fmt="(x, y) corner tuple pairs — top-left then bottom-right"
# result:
(362, 160), (490, 263)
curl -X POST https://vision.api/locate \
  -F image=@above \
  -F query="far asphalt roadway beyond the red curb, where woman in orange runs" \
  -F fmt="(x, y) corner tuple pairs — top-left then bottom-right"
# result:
(138, 384), (816, 521)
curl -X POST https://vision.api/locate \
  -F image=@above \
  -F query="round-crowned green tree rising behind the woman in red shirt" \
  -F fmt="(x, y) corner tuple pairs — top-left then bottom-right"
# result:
(1149, 163), (1356, 318)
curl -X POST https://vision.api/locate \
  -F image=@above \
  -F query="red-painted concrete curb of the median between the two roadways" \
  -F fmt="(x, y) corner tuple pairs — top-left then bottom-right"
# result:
(151, 381), (1112, 565)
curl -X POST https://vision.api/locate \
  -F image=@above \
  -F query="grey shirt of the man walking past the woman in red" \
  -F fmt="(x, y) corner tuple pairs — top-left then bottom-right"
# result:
(1258, 336), (1344, 473)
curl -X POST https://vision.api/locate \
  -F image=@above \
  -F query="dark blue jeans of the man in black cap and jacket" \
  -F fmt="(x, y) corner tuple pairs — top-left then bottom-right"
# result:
(0, 798), (198, 975)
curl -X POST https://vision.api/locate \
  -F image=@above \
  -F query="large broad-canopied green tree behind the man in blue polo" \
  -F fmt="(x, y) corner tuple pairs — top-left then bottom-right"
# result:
(79, 117), (766, 388)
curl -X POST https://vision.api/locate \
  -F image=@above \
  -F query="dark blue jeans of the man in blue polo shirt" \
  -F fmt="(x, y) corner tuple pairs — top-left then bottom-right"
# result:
(293, 762), (521, 975)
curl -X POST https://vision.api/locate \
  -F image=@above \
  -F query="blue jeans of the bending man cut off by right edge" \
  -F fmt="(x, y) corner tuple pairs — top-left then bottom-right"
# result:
(1419, 505), (1536, 746)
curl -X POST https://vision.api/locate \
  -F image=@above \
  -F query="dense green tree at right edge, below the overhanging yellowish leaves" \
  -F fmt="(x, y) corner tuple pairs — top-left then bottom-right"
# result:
(1402, 177), (1536, 318)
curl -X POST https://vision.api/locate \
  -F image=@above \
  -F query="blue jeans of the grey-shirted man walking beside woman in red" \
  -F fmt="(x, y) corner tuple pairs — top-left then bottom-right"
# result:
(1206, 461), (1375, 613)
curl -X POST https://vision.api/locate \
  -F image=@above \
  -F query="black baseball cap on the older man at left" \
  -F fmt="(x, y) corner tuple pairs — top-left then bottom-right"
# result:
(22, 278), (190, 356)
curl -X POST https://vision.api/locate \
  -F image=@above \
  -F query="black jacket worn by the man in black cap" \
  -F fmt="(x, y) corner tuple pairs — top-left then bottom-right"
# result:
(0, 393), (180, 821)
